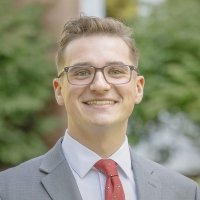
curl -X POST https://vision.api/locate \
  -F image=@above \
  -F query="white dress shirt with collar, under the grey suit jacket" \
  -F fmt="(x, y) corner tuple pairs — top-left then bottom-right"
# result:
(62, 131), (137, 200)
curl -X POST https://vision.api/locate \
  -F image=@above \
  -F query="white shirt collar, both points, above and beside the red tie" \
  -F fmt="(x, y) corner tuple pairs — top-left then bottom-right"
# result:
(62, 131), (132, 178)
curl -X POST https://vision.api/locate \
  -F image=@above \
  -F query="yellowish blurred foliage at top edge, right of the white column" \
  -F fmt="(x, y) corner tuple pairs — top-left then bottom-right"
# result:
(106, 0), (136, 21)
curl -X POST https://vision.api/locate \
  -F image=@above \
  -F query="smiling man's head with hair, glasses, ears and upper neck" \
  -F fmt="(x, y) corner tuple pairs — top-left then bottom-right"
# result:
(53, 17), (144, 146)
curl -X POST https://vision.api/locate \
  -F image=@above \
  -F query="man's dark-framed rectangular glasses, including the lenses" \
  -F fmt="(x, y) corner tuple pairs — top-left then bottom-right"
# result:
(58, 65), (139, 85)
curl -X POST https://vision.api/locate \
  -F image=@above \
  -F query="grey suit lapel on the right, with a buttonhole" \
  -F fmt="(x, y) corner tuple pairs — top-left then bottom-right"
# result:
(131, 151), (161, 200)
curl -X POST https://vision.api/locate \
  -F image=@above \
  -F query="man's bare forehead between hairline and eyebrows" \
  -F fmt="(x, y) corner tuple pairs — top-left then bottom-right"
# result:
(63, 35), (132, 66)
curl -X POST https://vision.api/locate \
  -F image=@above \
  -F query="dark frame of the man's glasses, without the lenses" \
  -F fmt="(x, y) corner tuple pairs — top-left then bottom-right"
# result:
(57, 64), (139, 85)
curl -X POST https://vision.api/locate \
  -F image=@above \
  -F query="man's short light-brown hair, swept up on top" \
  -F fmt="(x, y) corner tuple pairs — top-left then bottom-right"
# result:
(56, 16), (138, 71)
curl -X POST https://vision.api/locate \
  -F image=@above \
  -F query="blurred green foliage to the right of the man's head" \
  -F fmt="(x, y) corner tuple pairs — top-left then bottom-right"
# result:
(130, 0), (200, 141)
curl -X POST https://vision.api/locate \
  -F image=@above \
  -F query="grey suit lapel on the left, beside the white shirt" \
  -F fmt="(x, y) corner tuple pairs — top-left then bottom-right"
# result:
(40, 140), (82, 200)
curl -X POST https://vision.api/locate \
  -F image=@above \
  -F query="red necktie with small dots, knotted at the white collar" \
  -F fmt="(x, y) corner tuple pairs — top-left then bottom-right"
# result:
(94, 159), (125, 200)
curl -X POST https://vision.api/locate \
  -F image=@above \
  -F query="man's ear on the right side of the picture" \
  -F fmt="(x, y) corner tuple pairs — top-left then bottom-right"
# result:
(135, 76), (145, 104)
